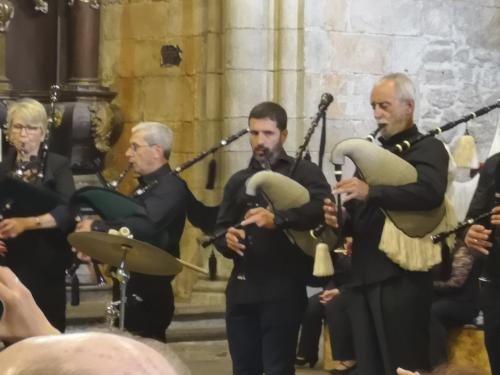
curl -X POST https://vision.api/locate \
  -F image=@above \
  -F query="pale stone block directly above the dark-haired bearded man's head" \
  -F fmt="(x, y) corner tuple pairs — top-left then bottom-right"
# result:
(223, 70), (272, 117)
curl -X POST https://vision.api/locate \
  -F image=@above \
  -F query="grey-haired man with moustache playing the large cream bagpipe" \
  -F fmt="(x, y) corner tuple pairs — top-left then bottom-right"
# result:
(324, 73), (448, 375)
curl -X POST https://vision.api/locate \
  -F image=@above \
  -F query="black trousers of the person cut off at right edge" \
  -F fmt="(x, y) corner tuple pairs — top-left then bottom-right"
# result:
(480, 283), (500, 375)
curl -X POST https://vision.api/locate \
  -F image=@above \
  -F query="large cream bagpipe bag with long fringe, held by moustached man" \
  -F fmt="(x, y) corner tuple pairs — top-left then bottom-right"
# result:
(331, 138), (457, 271)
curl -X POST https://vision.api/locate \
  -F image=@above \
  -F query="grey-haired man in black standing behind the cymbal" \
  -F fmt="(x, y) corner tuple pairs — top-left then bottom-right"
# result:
(77, 122), (188, 341)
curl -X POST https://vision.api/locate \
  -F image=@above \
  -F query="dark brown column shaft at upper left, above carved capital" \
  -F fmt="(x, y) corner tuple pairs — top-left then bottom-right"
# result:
(68, 0), (100, 86)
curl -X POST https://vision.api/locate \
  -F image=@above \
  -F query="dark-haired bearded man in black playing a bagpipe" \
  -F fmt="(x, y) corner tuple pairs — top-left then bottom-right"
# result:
(216, 102), (330, 375)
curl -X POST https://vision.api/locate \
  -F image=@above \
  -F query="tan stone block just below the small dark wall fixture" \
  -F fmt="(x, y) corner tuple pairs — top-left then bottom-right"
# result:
(141, 76), (193, 121)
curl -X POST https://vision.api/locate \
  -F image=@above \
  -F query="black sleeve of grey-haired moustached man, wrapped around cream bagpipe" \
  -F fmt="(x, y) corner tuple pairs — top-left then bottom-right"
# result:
(368, 139), (449, 211)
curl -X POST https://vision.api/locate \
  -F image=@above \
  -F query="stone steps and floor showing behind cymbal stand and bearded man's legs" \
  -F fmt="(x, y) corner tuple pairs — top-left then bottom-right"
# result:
(67, 274), (328, 375)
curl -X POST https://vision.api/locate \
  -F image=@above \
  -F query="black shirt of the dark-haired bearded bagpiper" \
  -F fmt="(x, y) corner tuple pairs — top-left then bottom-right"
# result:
(216, 152), (330, 303)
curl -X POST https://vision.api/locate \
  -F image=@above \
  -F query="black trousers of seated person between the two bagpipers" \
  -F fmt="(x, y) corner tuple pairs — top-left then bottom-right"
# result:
(297, 293), (355, 361)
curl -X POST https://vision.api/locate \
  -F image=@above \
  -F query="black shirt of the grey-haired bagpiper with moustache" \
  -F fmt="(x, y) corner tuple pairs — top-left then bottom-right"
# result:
(346, 126), (449, 285)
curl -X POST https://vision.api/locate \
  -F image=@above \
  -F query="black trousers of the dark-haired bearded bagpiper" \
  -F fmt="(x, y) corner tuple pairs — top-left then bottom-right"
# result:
(226, 298), (307, 375)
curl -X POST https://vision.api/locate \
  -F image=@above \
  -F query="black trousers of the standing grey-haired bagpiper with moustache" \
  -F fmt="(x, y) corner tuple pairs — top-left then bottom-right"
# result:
(345, 272), (432, 375)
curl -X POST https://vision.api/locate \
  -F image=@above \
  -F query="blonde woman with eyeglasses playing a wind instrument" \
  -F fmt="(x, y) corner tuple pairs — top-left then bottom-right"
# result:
(0, 98), (75, 331)
